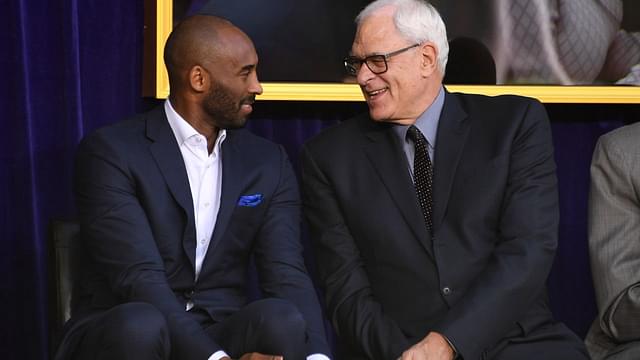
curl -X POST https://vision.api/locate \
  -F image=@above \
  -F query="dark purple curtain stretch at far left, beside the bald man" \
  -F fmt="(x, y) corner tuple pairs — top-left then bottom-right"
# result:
(0, 0), (158, 359)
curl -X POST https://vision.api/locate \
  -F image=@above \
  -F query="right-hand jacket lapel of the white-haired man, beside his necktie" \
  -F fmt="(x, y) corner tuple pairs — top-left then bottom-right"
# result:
(433, 92), (470, 234)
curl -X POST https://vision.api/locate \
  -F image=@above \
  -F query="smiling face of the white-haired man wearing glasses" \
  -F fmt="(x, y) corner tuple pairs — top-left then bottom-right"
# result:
(351, 6), (441, 125)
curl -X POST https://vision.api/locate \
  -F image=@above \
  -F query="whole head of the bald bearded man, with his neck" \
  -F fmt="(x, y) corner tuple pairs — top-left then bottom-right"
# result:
(164, 15), (262, 136)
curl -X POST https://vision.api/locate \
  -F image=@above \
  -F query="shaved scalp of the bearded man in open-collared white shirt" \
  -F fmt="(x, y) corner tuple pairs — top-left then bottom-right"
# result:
(164, 15), (253, 90)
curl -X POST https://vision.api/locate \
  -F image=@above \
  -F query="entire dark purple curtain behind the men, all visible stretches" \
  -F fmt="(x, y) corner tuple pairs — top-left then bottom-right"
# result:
(0, 0), (640, 359)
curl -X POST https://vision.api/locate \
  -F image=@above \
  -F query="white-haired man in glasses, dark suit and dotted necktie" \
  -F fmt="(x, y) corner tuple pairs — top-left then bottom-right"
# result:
(302, 0), (587, 360)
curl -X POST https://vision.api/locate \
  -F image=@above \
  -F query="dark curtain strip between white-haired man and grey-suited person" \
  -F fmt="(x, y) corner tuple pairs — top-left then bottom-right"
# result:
(546, 104), (640, 338)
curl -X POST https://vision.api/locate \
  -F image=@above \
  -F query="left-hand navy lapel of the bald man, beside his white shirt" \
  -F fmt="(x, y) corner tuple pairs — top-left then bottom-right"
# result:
(146, 106), (196, 269)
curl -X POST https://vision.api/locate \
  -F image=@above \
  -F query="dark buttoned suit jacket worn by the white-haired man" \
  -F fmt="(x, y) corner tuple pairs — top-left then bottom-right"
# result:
(302, 93), (558, 359)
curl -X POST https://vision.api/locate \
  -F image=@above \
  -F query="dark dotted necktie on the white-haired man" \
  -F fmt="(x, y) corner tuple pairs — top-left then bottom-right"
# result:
(407, 125), (433, 234)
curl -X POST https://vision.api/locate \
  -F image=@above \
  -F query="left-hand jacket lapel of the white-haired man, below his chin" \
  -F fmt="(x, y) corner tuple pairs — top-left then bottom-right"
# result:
(364, 118), (433, 256)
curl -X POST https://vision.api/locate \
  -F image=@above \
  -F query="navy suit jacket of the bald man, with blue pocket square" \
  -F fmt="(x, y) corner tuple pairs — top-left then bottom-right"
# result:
(58, 107), (328, 359)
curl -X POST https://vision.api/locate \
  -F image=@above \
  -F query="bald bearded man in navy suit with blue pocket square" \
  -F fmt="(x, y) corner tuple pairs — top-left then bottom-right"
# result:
(58, 15), (329, 360)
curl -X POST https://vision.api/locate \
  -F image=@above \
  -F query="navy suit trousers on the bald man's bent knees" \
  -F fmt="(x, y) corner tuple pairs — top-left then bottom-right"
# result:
(66, 298), (306, 360)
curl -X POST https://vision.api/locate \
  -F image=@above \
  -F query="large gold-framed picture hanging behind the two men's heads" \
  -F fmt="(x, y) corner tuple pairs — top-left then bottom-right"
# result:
(143, 0), (640, 103)
